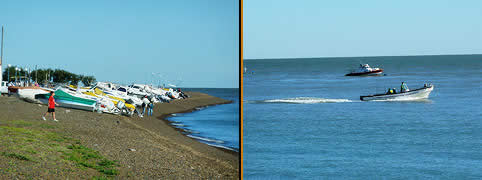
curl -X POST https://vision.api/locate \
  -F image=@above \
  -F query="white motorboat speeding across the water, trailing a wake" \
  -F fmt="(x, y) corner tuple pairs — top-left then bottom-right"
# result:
(360, 84), (434, 101)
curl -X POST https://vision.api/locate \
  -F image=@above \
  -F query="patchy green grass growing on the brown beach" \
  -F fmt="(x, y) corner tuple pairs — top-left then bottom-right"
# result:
(0, 121), (119, 179)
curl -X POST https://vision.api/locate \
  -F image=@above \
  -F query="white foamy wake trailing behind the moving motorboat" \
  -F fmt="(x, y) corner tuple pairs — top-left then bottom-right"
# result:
(245, 97), (354, 104)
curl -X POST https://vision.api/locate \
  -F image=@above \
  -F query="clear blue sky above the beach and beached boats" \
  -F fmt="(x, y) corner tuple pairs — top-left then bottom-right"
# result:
(0, 0), (239, 88)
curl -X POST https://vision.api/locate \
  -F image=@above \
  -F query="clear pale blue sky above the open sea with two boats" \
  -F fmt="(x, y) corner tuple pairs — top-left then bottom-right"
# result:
(243, 0), (482, 59)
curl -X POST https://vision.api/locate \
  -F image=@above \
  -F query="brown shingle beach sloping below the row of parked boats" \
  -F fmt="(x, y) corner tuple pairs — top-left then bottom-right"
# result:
(0, 92), (239, 179)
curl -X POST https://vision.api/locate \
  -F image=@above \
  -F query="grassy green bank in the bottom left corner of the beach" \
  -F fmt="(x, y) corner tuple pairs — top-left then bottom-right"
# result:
(0, 120), (119, 179)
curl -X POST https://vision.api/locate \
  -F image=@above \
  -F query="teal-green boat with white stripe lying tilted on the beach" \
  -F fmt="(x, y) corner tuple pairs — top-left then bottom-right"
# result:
(35, 89), (96, 111)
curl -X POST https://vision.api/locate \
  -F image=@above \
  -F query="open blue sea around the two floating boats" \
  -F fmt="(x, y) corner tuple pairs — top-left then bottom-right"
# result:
(243, 55), (482, 179)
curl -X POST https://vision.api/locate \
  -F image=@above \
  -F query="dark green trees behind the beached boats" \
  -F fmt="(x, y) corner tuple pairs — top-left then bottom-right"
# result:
(3, 66), (96, 86)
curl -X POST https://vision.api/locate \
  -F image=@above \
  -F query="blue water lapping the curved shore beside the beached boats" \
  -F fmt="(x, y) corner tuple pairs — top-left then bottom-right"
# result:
(168, 88), (239, 152)
